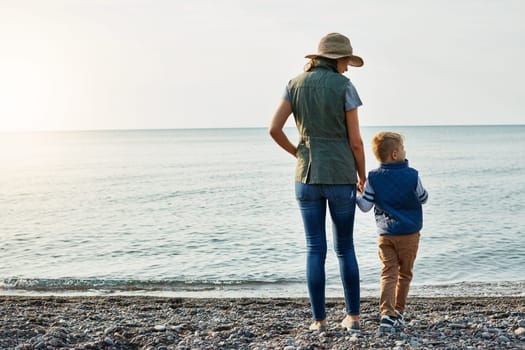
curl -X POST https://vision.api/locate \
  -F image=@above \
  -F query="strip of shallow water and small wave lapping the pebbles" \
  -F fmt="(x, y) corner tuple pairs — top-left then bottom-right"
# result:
(0, 279), (525, 298)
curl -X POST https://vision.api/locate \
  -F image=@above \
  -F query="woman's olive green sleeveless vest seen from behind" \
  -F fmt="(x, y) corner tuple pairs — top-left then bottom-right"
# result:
(288, 60), (357, 184)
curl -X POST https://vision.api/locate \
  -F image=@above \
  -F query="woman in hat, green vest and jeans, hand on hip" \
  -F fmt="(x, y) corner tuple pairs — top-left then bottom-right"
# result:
(269, 33), (366, 332)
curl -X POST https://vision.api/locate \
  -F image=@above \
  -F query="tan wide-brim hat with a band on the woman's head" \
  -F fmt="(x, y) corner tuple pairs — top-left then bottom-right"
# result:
(305, 33), (364, 67)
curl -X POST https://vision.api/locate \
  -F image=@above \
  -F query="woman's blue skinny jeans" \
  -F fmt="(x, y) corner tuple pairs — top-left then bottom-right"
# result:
(295, 182), (360, 321)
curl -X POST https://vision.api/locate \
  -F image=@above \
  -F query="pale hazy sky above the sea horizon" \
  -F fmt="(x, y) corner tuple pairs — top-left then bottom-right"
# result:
(0, 0), (525, 132)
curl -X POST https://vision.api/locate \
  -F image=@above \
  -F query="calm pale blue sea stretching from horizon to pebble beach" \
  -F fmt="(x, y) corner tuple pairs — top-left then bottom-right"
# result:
(0, 126), (525, 297)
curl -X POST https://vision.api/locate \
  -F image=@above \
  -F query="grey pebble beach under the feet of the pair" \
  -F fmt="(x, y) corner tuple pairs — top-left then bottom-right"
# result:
(0, 296), (525, 350)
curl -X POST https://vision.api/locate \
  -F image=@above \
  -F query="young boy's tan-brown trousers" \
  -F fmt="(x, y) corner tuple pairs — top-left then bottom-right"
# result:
(378, 232), (420, 317)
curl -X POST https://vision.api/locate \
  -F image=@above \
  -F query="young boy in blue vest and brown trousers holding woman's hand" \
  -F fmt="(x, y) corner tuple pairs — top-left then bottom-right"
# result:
(357, 132), (428, 331)
